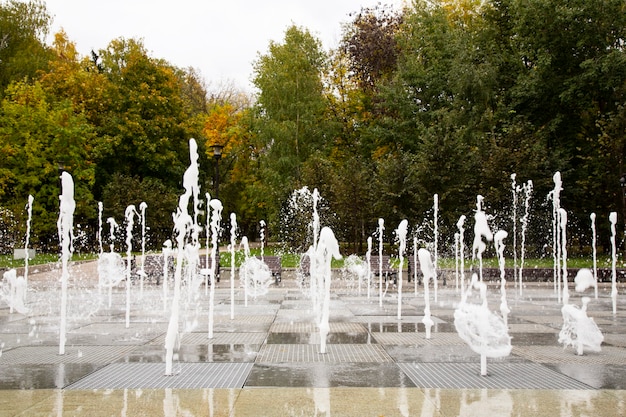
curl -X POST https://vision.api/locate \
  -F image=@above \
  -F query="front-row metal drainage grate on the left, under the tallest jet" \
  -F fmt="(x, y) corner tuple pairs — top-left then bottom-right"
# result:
(66, 363), (253, 389)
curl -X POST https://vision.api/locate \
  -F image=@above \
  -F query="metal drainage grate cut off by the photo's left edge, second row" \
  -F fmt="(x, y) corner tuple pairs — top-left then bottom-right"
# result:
(0, 346), (136, 365)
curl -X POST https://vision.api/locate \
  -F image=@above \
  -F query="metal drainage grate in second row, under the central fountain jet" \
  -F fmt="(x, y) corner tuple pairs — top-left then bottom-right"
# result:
(257, 344), (392, 363)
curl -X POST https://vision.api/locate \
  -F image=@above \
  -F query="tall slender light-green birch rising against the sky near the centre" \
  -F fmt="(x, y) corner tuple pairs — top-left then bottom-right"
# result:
(253, 26), (327, 231)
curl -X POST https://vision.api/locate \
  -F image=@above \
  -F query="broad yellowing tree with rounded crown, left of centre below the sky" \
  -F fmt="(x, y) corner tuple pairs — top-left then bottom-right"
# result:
(97, 39), (202, 193)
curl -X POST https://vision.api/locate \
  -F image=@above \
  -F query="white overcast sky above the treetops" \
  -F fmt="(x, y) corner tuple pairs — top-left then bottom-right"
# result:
(46, 0), (404, 91)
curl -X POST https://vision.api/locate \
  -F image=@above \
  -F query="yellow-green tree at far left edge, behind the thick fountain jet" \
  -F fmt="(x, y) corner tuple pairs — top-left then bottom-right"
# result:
(0, 82), (95, 249)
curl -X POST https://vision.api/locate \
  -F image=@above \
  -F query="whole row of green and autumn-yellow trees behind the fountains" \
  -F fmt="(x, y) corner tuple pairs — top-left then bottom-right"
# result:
(0, 0), (626, 255)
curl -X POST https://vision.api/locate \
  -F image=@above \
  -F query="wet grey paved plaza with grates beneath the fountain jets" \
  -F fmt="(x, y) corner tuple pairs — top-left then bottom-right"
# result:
(0, 263), (626, 416)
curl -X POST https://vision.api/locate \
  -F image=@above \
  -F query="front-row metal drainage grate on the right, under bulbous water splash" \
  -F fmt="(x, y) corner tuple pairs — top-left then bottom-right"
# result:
(398, 363), (593, 390)
